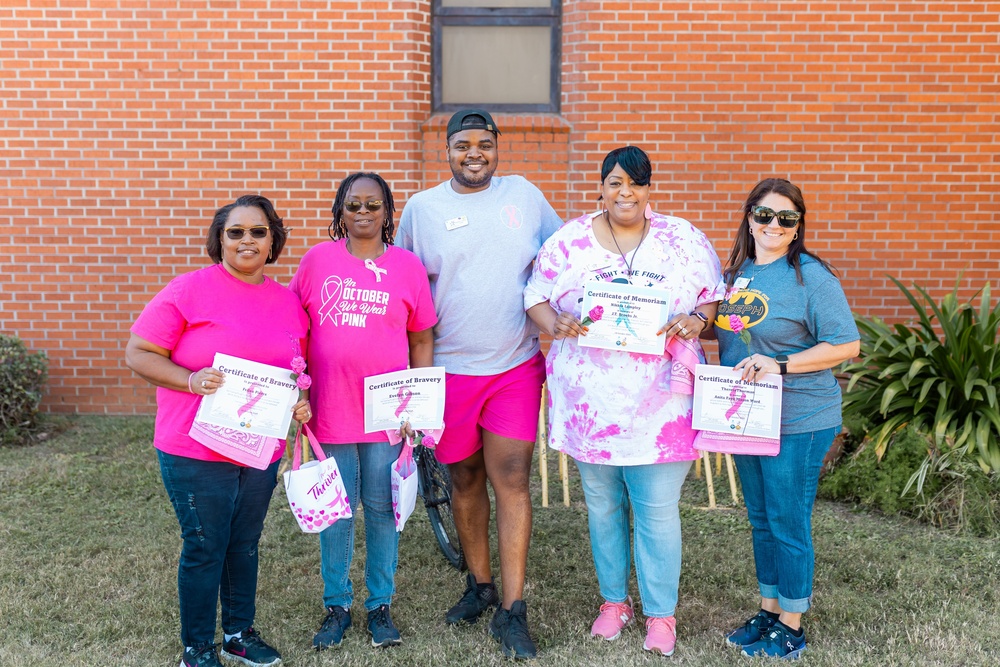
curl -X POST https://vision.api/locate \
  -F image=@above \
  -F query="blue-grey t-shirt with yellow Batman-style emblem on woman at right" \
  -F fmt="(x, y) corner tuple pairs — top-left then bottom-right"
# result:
(715, 255), (860, 434)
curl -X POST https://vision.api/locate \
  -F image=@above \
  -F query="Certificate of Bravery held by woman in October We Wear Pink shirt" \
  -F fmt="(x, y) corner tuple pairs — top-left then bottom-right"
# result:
(365, 366), (444, 433)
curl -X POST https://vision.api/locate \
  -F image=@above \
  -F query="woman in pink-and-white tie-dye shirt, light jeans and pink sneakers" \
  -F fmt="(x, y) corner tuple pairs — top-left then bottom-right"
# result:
(524, 146), (721, 655)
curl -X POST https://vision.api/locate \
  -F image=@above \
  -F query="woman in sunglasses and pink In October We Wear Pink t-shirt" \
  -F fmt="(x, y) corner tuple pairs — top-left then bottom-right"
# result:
(289, 173), (437, 649)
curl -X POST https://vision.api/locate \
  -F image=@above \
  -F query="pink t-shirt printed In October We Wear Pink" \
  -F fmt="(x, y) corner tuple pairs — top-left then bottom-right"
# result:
(289, 239), (437, 444)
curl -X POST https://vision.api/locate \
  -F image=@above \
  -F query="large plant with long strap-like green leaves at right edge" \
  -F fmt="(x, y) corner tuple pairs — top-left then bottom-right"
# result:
(843, 278), (1000, 491)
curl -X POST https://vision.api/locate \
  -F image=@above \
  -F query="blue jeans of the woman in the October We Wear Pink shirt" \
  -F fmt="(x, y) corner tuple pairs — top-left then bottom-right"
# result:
(319, 442), (403, 611)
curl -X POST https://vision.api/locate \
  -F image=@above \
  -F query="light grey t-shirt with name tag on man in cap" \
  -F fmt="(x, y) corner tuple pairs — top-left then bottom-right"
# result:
(396, 176), (562, 376)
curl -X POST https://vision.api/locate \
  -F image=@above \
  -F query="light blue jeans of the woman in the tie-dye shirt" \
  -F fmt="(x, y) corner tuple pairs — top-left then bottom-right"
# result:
(576, 461), (691, 618)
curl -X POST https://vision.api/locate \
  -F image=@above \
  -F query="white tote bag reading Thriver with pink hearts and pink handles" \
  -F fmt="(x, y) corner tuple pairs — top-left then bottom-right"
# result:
(284, 424), (351, 533)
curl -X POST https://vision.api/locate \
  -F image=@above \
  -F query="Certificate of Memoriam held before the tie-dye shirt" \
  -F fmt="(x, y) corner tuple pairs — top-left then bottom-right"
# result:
(577, 282), (671, 354)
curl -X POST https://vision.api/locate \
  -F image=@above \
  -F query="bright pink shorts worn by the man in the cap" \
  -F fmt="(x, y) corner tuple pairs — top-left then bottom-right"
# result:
(435, 352), (545, 463)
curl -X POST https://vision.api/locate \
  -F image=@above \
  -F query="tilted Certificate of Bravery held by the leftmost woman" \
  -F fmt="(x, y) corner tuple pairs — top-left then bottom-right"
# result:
(195, 353), (299, 438)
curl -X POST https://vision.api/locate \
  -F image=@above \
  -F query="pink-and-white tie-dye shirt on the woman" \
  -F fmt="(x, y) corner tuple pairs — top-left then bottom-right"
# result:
(524, 211), (722, 465)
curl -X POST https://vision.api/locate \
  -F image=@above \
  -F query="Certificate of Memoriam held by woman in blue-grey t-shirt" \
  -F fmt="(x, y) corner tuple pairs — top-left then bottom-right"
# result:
(691, 364), (782, 438)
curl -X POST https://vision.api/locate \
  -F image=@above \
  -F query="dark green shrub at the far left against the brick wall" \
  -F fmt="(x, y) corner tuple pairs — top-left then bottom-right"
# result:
(0, 334), (49, 445)
